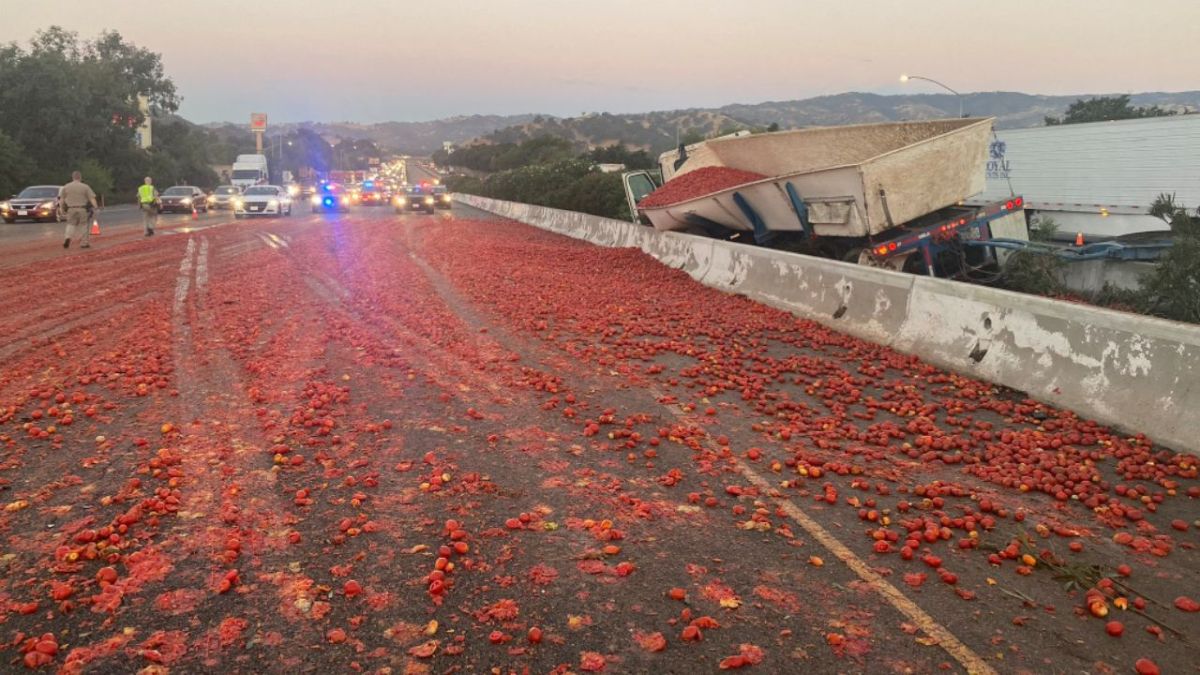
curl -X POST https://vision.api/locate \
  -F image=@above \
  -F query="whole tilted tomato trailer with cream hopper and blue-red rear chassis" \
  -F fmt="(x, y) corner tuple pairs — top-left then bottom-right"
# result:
(625, 119), (1027, 276)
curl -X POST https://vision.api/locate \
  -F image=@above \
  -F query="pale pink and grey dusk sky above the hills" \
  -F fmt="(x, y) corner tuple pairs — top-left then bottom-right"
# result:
(0, 0), (1200, 123)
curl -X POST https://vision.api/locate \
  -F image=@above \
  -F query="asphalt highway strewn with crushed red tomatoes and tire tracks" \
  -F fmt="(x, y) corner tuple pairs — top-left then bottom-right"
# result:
(0, 198), (1200, 674)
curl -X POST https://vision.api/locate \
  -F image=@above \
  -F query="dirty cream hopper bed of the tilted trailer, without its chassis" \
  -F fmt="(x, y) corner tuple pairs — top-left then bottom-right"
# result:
(638, 118), (992, 238)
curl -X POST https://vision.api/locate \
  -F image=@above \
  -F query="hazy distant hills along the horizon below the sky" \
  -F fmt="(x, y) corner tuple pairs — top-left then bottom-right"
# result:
(206, 91), (1200, 155)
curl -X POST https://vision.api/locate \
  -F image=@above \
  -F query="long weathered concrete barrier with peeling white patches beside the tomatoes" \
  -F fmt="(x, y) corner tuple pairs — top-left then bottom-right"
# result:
(455, 195), (1200, 452)
